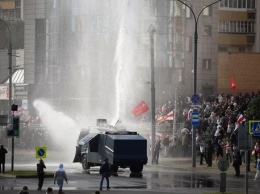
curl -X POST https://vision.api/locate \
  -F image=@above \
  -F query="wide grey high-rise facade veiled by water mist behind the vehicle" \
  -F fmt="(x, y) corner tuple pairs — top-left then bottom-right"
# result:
(24, 0), (219, 121)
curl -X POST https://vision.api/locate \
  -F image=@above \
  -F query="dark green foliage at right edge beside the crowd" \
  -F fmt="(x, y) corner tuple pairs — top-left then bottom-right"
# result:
(246, 97), (260, 120)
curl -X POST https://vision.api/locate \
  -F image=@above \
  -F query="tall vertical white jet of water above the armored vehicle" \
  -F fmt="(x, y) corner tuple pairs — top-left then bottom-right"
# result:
(112, 1), (140, 125)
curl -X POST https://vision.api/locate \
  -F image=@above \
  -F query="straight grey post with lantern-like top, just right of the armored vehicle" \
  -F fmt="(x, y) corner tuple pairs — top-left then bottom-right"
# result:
(149, 25), (156, 162)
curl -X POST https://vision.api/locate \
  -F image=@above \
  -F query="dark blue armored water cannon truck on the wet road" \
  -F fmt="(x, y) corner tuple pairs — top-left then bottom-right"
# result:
(73, 119), (148, 172)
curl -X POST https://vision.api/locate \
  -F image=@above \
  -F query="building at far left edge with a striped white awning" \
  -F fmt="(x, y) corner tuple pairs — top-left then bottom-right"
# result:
(0, 0), (24, 114)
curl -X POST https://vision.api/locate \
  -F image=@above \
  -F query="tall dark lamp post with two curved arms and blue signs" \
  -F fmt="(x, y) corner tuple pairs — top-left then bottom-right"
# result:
(176, 0), (221, 167)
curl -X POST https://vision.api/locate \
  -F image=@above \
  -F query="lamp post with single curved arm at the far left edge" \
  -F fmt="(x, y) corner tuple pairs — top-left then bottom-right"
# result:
(0, 19), (14, 171)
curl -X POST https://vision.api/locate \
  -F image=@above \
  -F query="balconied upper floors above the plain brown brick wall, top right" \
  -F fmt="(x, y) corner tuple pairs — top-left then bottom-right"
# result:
(218, 0), (260, 52)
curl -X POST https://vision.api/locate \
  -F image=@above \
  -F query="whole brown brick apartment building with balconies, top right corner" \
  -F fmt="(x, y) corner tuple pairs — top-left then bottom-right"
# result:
(218, 0), (260, 94)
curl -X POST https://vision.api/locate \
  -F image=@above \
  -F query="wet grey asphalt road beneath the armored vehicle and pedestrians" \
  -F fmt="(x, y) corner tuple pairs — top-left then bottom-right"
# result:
(0, 150), (260, 194)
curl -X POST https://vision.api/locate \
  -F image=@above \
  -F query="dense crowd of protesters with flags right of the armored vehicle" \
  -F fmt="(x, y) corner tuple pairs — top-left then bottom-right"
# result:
(153, 93), (260, 177)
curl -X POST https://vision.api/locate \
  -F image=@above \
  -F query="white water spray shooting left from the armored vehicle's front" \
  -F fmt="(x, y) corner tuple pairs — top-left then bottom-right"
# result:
(33, 100), (80, 162)
